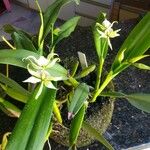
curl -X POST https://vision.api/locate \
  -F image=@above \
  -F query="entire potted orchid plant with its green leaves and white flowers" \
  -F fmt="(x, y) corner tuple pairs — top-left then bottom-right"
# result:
(0, 0), (150, 150)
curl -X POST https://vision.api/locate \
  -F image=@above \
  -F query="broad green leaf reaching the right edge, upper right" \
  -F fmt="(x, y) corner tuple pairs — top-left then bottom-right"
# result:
(112, 12), (150, 70)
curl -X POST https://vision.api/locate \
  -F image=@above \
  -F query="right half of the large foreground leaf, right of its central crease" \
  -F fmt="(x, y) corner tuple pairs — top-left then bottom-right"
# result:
(26, 88), (56, 150)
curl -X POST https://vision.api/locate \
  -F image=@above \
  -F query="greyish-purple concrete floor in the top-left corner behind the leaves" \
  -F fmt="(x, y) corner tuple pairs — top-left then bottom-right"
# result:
(0, 4), (40, 41)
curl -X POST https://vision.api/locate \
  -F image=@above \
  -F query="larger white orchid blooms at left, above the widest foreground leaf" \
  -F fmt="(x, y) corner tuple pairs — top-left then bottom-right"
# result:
(23, 53), (62, 89)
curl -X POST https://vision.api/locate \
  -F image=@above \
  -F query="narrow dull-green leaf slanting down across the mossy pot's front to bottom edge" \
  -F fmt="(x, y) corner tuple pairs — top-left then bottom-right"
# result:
(82, 121), (114, 150)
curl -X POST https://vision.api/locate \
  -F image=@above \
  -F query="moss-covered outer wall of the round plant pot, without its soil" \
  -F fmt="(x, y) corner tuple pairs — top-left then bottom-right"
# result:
(51, 100), (114, 147)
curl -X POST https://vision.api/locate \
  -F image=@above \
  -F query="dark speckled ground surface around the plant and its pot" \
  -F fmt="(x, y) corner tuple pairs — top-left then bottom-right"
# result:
(0, 18), (150, 150)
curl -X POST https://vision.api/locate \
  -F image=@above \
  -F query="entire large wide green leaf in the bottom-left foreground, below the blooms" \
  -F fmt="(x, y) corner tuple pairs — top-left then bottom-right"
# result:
(6, 84), (56, 150)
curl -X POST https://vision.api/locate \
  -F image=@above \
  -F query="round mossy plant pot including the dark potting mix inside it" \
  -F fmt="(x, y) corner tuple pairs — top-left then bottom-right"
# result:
(50, 73), (114, 147)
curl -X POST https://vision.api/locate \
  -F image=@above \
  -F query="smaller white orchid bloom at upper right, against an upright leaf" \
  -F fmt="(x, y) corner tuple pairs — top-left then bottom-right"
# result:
(96, 19), (121, 49)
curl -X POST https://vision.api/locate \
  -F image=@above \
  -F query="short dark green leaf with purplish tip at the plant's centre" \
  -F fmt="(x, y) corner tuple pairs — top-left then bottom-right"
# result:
(68, 83), (89, 119)
